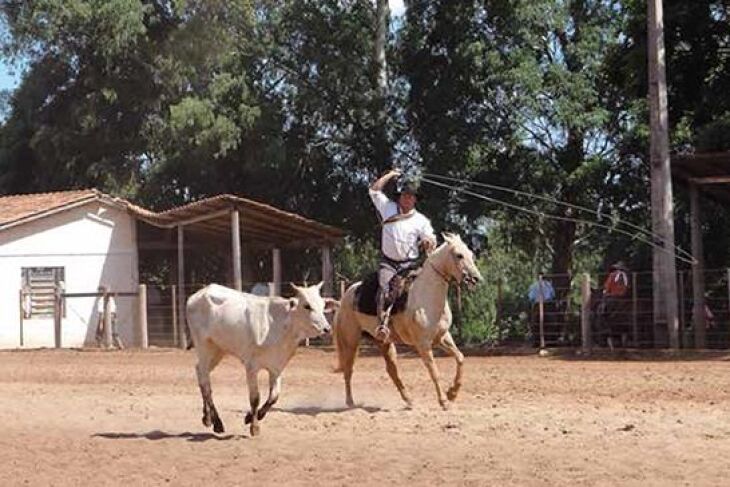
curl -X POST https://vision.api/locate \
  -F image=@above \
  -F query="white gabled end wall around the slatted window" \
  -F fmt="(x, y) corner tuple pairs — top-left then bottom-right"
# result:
(0, 201), (139, 348)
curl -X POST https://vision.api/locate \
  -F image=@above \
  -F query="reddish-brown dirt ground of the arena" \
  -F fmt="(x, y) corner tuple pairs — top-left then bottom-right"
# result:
(0, 349), (730, 486)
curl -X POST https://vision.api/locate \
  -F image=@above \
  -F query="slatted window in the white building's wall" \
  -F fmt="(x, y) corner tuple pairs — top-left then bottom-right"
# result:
(21, 267), (66, 318)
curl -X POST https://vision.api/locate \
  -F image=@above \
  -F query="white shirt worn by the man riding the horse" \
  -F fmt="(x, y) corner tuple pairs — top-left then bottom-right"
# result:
(369, 189), (436, 261)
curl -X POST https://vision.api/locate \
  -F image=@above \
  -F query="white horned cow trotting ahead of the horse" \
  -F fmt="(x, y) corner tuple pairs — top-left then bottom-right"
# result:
(187, 283), (337, 436)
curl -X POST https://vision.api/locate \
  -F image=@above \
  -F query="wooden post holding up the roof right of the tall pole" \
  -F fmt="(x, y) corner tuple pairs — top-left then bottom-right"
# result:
(689, 183), (707, 348)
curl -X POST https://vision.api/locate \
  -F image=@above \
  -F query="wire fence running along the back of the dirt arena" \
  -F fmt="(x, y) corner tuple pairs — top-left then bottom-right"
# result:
(19, 269), (730, 349)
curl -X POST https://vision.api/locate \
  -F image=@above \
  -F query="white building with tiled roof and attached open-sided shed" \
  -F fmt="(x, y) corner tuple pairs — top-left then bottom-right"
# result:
(0, 189), (342, 348)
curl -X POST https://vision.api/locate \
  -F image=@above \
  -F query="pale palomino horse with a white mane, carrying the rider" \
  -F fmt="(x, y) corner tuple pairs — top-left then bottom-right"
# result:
(333, 234), (482, 409)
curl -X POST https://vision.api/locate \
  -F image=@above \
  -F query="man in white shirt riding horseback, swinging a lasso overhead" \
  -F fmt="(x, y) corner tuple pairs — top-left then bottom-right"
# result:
(369, 169), (436, 342)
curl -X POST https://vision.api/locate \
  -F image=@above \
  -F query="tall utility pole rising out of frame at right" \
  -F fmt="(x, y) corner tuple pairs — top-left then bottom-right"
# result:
(647, 0), (679, 349)
